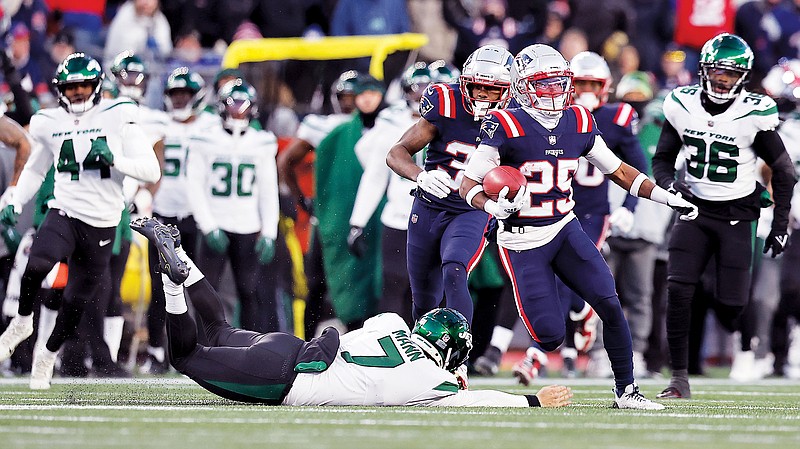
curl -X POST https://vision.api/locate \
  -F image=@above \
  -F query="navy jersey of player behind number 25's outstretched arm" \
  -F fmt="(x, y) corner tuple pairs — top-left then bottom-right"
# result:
(573, 103), (647, 217)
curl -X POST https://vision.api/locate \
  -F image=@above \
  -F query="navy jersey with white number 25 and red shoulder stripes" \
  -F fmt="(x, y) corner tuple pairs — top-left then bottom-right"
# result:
(481, 106), (600, 226)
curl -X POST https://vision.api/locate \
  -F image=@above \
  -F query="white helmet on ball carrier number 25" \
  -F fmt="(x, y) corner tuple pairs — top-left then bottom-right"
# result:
(511, 44), (574, 113)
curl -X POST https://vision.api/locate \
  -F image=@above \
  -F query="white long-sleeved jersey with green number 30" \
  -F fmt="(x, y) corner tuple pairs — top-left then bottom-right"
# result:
(186, 120), (278, 239)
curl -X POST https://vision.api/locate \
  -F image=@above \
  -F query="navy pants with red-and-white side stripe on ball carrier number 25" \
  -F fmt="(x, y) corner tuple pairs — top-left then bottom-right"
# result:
(501, 220), (633, 388)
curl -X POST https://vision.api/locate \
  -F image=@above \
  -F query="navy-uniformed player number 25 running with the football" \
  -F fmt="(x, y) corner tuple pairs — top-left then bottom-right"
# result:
(460, 44), (697, 410)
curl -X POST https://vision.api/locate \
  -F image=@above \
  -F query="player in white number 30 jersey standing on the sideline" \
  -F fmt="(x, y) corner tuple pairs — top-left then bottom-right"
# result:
(186, 78), (278, 330)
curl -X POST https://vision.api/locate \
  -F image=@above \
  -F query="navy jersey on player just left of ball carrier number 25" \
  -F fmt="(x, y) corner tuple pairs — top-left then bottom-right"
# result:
(418, 83), (481, 211)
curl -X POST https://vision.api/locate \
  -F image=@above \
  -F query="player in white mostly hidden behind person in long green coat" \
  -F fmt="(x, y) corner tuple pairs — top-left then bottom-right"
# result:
(277, 70), (358, 336)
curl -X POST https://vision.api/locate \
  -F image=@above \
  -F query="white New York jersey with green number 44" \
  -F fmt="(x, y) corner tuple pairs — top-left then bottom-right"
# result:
(26, 98), (157, 227)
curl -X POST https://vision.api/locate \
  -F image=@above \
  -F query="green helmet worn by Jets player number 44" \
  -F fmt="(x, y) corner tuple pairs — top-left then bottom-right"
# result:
(51, 53), (105, 114)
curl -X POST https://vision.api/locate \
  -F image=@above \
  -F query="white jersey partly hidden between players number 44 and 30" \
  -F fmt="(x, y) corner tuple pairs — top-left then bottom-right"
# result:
(153, 113), (219, 218)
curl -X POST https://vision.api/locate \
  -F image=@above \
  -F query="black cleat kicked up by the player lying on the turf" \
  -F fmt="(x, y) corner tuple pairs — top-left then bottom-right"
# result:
(131, 217), (189, 285)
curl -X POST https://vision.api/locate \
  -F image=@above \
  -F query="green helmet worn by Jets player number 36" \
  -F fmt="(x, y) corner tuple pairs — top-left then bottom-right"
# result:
(699, 33), (753, 100)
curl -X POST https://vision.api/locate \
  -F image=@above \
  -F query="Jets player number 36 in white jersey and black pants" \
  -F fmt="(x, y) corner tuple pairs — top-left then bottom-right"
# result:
(653, 33), (795, 398)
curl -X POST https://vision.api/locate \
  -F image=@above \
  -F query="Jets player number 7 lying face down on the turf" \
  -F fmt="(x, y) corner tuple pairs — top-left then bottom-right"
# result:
(131, 218), (572, 407)
